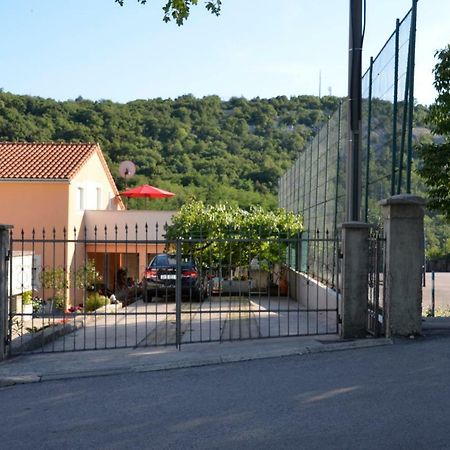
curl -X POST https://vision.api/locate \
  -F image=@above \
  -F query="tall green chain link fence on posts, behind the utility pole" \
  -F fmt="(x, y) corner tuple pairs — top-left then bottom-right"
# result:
(278, 0), (416, 236)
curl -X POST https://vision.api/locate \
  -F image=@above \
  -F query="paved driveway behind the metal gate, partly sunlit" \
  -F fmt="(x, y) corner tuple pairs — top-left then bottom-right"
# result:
(40, 297), (336, 351)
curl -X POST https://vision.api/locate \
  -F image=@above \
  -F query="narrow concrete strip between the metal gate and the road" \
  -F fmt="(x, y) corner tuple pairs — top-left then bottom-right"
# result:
(0, 339), (393, 387)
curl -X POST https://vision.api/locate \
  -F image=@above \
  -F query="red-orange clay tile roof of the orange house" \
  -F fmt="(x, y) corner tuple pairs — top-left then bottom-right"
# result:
(0, 142), (102, 180)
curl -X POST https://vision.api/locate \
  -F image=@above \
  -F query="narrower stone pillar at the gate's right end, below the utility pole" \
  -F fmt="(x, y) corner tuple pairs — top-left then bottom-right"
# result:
(340, 222), (370, 338)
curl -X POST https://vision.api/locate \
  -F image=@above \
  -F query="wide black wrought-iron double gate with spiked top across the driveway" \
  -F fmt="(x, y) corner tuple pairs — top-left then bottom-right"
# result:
(7, 226), (338, 354)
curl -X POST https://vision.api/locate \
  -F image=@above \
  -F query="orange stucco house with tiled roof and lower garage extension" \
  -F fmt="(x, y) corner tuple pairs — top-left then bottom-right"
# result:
(0, 142), (173, 303)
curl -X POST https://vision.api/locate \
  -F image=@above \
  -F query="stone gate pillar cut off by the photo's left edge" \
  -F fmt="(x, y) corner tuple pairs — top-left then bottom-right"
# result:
(0, 225), (12, 361)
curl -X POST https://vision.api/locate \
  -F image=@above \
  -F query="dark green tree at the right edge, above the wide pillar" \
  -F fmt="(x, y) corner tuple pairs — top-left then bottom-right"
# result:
(418, 45), (450, 220)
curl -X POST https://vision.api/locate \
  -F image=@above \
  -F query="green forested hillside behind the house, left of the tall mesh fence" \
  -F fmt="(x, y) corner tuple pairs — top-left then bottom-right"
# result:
(0, 92), (339, 209)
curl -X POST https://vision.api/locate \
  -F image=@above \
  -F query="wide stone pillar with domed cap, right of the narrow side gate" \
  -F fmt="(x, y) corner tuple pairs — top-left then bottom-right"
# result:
(380, 194), (425, 337)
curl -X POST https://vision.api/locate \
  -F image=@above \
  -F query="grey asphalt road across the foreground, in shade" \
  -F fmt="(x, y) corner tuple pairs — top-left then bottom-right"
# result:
(0, 337), (450, 450)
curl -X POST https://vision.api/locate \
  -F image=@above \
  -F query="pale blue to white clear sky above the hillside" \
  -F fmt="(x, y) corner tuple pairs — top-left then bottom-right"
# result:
(0, 0), (450, 104)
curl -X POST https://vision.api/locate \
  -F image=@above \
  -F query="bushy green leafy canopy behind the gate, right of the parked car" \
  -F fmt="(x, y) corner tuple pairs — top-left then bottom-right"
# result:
(166, 201), (303, 268)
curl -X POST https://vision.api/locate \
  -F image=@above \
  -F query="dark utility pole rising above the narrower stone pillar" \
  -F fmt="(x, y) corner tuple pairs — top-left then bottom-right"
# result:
(346, 0), (362, 222)
